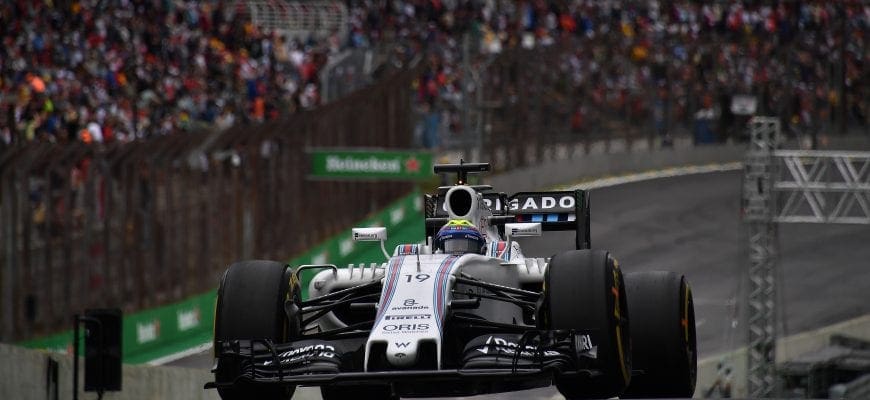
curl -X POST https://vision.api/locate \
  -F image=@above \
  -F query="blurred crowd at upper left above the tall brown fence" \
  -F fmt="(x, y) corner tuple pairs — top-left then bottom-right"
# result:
(0, 0), (324, 144)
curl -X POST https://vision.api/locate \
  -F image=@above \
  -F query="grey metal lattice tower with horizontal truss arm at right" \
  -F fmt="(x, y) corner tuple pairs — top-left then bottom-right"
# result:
(743, 117), (870, 398)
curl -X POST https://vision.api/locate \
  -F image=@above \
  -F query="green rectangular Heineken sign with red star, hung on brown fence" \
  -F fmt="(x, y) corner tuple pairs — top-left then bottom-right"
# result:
(309, 149), (432, 180)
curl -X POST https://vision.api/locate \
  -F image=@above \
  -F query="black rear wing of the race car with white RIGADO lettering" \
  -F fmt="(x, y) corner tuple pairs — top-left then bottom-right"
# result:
(424, 190), (591, 250)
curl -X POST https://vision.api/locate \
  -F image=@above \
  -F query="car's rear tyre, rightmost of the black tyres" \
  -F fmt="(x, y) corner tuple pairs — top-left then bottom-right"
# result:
(621, 271), (698, 398)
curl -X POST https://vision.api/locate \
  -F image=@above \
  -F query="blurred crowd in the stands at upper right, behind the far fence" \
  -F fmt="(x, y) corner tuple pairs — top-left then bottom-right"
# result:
(349, 0), (870, 147)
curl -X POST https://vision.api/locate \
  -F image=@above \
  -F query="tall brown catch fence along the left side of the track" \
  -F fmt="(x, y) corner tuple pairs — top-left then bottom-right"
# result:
(0, 64), (419, 341)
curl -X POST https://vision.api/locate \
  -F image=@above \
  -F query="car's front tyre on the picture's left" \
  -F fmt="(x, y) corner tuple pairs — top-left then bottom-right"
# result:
(214, 260), (300, 400)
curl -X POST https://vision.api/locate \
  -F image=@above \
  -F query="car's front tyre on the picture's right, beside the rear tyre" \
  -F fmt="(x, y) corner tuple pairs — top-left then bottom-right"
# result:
(538, 250), (632, 399)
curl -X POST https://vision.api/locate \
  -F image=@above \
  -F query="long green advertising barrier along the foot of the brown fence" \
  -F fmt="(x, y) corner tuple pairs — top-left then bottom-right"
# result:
(18, 191), (423, 364)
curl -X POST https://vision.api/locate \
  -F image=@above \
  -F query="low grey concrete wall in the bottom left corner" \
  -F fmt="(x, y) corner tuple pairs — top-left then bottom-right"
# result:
(0, 343), (219, 400)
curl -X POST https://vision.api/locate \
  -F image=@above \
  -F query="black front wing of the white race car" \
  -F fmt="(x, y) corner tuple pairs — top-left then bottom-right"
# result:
(205, 331), (600, 395)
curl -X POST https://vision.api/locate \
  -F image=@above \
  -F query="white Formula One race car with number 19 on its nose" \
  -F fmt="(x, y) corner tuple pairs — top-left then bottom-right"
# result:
(206, 162), (697, 400)
